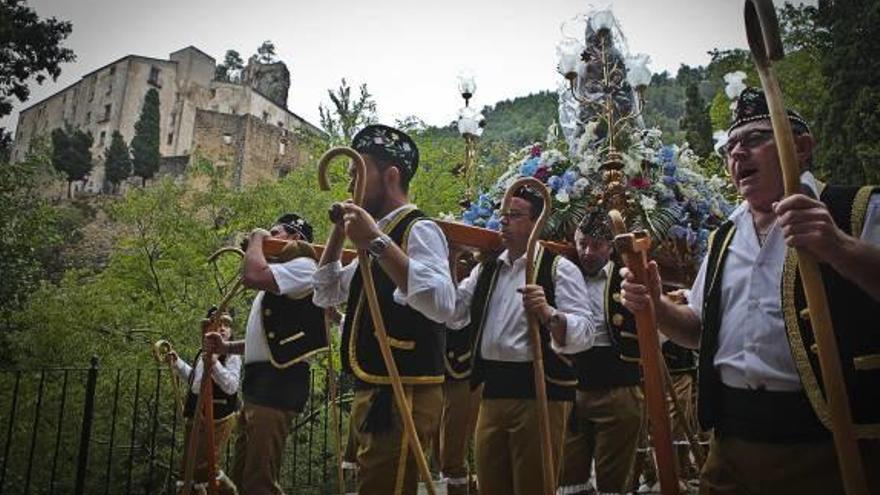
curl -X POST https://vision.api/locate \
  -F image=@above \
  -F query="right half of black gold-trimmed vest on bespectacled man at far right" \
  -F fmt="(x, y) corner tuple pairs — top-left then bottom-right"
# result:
(781, 186), (880, 438)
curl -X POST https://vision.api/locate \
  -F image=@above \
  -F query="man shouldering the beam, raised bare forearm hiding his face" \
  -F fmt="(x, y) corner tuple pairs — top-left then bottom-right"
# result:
(205, 213), (327, 495)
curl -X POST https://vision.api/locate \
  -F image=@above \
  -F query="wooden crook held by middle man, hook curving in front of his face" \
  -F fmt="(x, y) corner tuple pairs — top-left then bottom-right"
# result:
(501, 177), (556, 495)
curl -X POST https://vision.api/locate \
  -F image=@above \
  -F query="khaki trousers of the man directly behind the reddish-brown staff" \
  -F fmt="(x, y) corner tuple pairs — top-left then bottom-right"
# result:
(560, 385), (643, 493)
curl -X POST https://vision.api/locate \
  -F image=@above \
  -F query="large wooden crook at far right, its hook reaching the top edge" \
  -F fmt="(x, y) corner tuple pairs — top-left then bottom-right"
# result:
(745, 0), (868, 495)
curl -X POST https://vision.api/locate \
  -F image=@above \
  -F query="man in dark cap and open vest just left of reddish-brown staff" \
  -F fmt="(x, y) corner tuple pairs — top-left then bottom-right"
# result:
(560, 208), (644, 495)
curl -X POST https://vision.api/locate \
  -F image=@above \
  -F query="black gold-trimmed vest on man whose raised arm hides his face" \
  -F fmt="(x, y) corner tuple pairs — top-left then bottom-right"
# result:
(260, 290), (330, 369)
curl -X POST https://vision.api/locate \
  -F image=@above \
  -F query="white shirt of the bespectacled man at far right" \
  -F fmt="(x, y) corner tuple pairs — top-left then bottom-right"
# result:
(689, 172), (880, 391)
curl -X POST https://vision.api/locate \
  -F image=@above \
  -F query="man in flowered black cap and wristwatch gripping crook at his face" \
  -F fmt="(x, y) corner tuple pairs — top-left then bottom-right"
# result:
(314, 125), (455, 495)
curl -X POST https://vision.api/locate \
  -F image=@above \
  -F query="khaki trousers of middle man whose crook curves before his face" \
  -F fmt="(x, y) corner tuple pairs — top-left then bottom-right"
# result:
(476, 399), (571, 495)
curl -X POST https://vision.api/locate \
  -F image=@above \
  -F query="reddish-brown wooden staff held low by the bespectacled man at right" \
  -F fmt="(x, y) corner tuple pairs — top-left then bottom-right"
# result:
(608, 210), (679, 495)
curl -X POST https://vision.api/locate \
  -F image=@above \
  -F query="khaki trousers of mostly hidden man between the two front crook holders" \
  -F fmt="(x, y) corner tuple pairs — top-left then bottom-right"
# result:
(439, 379), (482, 495)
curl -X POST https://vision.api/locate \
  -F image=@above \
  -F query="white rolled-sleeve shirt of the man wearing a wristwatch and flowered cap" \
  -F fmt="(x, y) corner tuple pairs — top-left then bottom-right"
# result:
(313, 205), (455, 323)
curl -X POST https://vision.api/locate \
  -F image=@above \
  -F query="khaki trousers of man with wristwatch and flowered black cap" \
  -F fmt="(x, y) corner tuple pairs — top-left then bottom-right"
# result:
(351, 384), (443, 495)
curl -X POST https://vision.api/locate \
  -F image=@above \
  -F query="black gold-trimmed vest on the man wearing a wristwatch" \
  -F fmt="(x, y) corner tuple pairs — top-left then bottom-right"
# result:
(342, 208), (445, 385)
